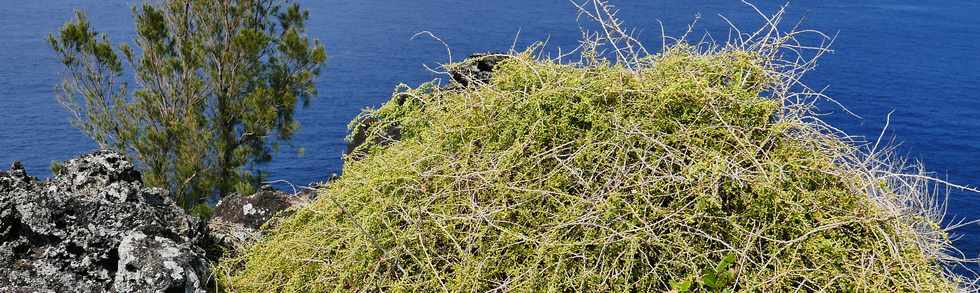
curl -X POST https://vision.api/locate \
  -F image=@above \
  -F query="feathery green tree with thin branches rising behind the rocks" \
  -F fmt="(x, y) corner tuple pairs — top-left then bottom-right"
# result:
(49, 0), (326, 208)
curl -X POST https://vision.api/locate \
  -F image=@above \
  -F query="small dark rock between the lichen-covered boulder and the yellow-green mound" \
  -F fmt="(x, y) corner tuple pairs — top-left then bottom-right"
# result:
(208, 186), (310, 254)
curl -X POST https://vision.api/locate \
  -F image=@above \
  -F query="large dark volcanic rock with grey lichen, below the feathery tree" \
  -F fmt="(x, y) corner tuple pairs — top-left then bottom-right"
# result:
(0, 151), (208, 292)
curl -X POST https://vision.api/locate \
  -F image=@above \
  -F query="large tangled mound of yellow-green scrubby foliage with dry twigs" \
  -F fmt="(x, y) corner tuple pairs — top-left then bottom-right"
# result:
(219, 47), (955, 292)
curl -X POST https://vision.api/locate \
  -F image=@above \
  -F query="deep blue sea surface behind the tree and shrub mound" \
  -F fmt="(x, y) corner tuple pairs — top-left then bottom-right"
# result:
(0, 0), (980, 266)
